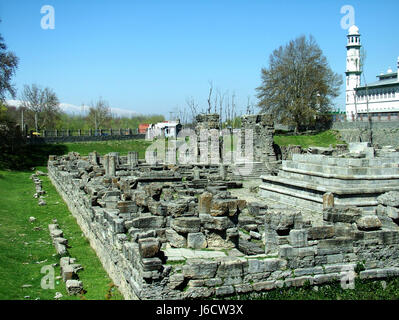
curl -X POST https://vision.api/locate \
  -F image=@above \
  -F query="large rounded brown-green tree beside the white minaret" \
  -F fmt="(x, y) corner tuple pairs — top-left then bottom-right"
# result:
(256, 36), (342, 131)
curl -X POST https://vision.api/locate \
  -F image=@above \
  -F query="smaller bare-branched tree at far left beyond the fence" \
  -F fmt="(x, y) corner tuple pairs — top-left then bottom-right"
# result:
(21, 84), (61, 131)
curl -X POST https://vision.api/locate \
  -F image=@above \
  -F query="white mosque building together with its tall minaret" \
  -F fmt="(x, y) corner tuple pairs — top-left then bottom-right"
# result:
(345, 25), (399, 121)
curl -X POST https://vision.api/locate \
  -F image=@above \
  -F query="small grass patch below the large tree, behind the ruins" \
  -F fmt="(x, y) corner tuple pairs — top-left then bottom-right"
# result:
(274, 130), (345, 148)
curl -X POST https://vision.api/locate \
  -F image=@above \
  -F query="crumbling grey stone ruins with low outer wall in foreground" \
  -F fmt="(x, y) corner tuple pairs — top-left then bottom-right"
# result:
(48, 148), (399, 299)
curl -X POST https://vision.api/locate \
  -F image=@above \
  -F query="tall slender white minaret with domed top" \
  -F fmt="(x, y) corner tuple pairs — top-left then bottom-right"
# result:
(345, 25), (362, 121)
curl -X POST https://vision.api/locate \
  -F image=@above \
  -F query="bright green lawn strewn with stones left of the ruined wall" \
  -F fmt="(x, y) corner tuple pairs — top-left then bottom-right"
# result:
(0, 167), (123, 300)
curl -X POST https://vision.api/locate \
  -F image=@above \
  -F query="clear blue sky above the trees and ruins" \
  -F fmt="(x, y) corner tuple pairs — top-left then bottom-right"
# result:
(0, 0), (399, 116)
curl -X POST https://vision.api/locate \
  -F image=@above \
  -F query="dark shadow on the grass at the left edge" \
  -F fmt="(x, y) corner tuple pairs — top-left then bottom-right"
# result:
(0, 144), (68, 170)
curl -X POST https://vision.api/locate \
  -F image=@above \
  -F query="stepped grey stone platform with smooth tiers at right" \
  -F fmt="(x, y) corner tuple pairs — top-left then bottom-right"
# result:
(259, 152), (399, 211)
